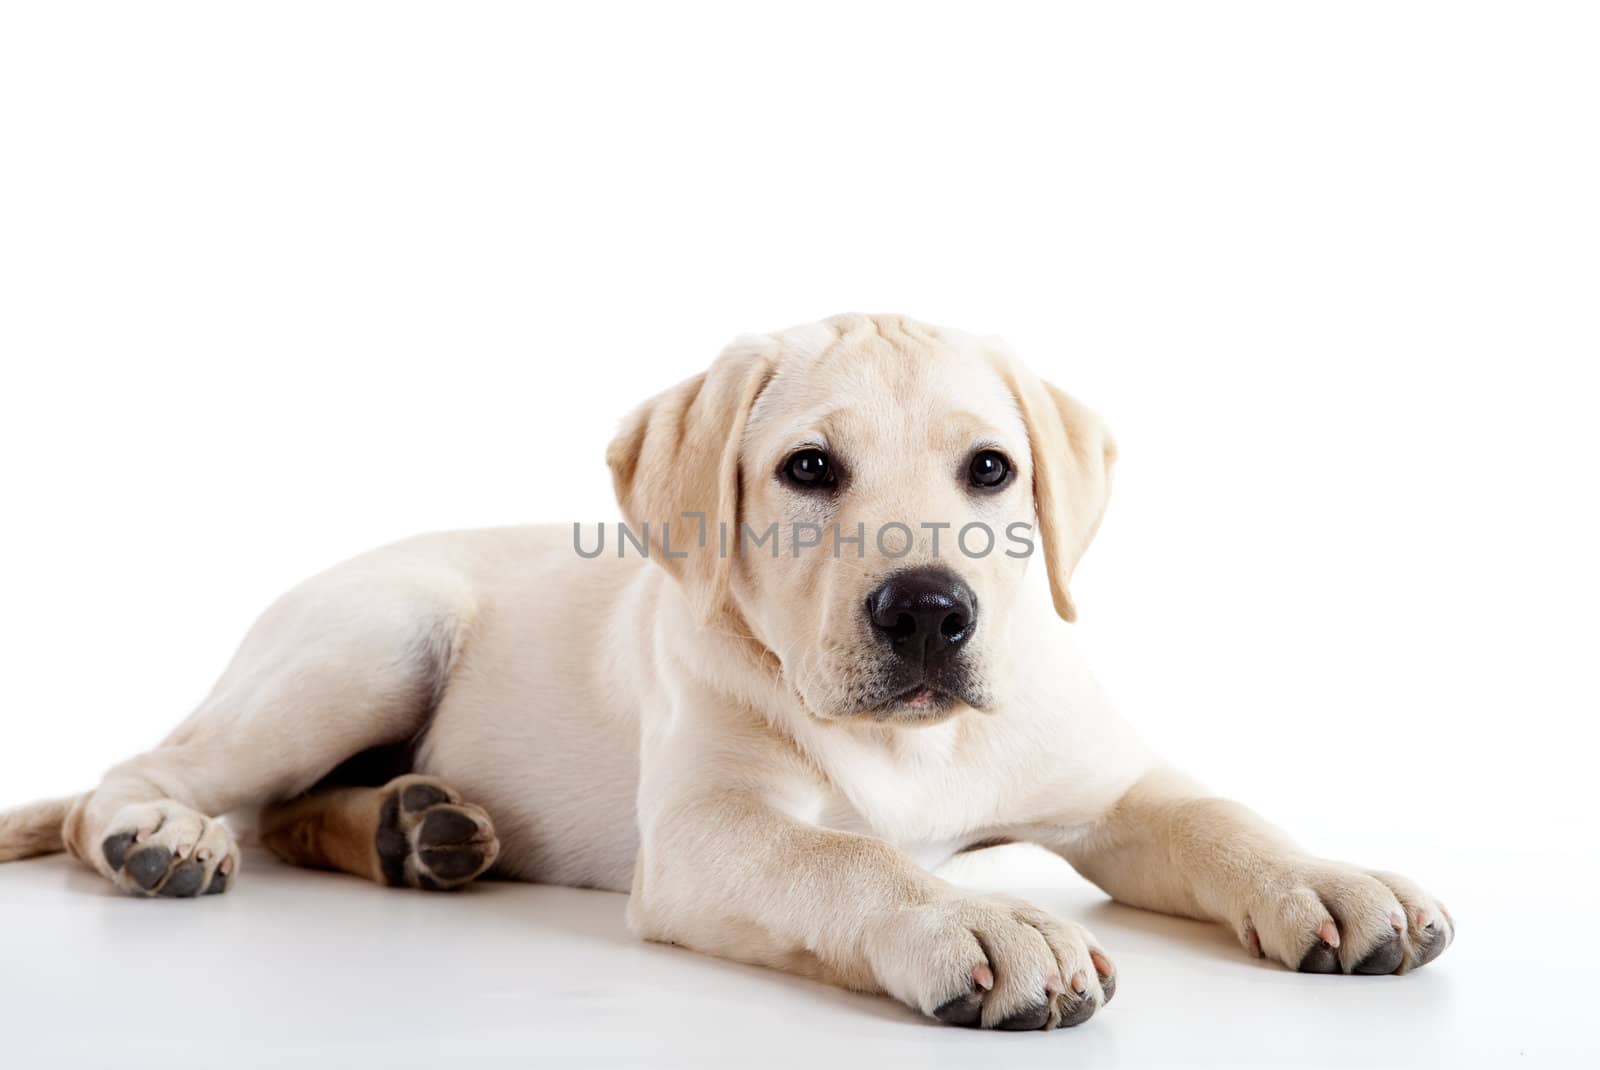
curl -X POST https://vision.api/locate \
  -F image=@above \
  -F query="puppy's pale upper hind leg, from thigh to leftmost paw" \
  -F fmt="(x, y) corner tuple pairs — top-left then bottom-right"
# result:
(62, 544), (475, 897)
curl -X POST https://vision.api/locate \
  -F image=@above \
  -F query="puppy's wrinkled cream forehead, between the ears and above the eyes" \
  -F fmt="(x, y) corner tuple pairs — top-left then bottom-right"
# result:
(744, 331), (1026, 451)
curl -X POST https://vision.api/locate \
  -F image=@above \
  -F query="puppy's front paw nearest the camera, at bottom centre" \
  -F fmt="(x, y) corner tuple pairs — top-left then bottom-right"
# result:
(872, 896), (1117, 1030)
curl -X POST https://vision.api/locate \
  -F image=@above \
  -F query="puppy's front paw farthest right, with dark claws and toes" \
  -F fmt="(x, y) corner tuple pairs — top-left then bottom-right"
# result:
(1235, 860), (1456, 974)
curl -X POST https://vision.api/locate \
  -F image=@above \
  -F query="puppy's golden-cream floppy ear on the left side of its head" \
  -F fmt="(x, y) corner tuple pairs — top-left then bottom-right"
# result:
(606, 345), (773, 624)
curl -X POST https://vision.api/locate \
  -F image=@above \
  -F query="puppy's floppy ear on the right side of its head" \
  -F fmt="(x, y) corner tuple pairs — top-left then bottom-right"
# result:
(1000, 351), (1117, 621)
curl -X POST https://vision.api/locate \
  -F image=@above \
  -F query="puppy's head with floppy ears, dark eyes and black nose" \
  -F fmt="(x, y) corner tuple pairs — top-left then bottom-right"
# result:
(606, 317), (1115, 723)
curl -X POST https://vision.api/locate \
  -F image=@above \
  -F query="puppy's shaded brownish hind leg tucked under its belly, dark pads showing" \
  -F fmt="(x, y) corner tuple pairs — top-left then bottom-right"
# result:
(261, 774), (499, 891)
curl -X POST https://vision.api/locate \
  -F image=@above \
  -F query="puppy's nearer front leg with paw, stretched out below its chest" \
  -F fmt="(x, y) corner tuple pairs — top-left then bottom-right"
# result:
(629, 777), (1115, 1030)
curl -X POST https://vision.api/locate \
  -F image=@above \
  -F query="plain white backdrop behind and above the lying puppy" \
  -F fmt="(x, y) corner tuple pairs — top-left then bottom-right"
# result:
(0, 3), (1600, 1054)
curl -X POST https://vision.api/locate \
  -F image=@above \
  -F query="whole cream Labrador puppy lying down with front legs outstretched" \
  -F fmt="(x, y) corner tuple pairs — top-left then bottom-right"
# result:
(0, 315), (1454, 1030)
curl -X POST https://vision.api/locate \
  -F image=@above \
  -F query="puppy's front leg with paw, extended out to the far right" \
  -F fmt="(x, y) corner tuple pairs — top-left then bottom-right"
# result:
(1053, 769), (1454, 974)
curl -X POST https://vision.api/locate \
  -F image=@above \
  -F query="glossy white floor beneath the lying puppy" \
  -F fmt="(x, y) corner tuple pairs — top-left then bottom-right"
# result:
(0, 848), (1600, 1070)
